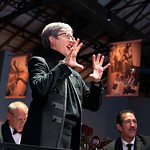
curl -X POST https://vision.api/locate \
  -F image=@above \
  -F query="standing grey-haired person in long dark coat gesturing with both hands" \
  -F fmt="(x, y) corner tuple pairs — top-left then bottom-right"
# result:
(21, 22), (110, 150)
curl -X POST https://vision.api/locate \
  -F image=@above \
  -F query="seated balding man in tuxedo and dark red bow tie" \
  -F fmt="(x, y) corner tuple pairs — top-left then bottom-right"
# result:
(0, 101), (28, 144)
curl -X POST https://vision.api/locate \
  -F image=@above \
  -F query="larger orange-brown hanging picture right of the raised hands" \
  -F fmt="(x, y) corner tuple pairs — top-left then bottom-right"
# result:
(106, 40), (141, 96)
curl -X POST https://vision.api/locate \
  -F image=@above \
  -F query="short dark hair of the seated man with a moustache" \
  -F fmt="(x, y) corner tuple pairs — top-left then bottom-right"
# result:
(116, 110), (135, 126)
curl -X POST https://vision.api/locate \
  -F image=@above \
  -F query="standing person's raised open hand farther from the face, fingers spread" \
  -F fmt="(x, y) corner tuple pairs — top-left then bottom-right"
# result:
(89, 54), (110, 82)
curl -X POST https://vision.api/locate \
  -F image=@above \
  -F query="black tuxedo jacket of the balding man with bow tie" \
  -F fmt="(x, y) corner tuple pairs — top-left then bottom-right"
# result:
(0, 121), (15, 148)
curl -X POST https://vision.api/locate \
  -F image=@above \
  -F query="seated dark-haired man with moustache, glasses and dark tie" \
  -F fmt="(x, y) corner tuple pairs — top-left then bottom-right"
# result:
(104, 110), (150, 150)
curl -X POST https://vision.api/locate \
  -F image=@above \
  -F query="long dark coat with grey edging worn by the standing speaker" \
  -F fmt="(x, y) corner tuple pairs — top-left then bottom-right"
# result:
(21, 50), (103, 150)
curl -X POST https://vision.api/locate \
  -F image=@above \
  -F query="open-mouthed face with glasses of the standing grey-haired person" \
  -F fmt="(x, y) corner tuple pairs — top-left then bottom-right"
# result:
(49, 30), (74, 56)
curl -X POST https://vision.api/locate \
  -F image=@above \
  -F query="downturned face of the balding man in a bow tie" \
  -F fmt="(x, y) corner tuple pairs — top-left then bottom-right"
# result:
(7, 108), (28, 132)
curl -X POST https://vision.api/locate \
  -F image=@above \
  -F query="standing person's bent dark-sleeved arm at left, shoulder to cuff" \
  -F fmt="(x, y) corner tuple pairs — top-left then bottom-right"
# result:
(28, 57), (71, 95)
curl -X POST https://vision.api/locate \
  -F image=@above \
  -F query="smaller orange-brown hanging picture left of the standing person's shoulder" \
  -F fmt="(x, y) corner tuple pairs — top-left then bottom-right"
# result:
(5, 55), (29, 98)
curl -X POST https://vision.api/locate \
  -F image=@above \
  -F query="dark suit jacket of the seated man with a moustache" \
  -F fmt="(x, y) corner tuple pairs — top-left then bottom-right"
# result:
(104, 135), (150, 150)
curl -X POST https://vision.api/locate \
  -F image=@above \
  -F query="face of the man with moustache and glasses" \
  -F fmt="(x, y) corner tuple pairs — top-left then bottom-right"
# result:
(117, 113), (137, 142)
